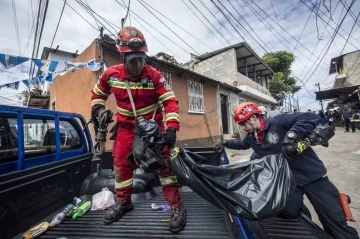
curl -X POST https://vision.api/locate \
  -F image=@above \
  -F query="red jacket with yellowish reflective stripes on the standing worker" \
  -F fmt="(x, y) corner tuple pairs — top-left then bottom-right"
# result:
(91, 64), (179, 130)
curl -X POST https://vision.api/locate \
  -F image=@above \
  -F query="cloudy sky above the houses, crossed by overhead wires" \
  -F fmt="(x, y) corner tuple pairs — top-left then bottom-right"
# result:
(0, 0), (360, 111)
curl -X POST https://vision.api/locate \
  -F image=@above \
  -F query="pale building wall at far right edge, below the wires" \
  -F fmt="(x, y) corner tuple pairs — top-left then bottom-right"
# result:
(343, 51), (360, 85)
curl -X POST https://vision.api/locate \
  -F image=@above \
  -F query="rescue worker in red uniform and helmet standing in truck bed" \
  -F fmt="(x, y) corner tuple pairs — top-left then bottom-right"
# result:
(91, 27), (186, 232)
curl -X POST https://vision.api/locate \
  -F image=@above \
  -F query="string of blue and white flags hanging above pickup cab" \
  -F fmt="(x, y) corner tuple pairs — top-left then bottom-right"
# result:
(0, 53), (104, 90)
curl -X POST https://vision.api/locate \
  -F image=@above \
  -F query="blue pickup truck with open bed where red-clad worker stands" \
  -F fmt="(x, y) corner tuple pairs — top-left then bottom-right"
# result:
(0, 105), (330, 239)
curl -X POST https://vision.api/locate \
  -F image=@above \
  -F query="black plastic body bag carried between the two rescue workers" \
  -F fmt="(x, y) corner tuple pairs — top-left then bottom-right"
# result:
(170, 148), (296, 220)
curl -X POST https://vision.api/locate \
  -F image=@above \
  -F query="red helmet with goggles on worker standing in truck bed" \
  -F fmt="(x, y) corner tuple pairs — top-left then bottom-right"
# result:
(116, 27), (147, 53)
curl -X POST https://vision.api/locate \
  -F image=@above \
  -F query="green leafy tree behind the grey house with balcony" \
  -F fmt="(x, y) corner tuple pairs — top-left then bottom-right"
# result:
(262, 51), (301, 106)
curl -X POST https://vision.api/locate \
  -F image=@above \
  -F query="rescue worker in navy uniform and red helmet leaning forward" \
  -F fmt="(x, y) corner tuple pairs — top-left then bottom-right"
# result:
(219, 102), (359, 238)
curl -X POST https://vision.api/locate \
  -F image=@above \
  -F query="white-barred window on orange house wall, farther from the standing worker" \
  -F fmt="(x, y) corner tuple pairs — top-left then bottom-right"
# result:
(187, 78), (204, 113)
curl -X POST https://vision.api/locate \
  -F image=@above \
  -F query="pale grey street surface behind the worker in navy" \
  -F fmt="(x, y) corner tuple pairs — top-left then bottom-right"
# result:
(226, 127), (360, 234)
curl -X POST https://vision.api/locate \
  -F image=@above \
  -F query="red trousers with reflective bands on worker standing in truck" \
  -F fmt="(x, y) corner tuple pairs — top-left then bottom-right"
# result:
(113, 126), (181, 208)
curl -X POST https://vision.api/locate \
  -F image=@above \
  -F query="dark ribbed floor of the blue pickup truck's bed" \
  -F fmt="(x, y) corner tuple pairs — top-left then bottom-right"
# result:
(40, 192), (235, 239)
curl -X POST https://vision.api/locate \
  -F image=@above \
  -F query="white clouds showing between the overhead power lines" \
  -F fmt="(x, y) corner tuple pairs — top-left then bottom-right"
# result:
(0, 0), (360, 110)
